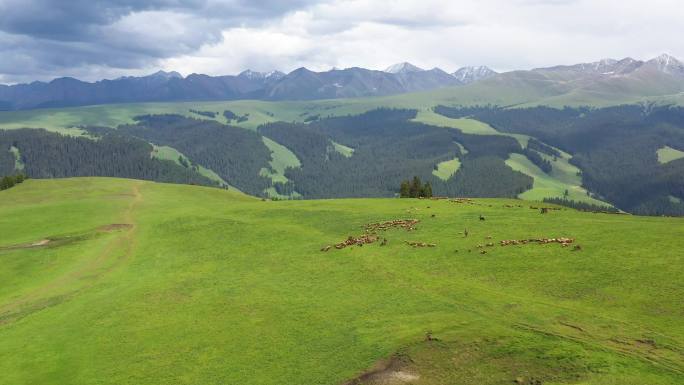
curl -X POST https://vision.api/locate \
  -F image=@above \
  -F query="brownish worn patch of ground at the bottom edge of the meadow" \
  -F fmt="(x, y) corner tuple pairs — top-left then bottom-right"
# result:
(343, 338), (586, 385)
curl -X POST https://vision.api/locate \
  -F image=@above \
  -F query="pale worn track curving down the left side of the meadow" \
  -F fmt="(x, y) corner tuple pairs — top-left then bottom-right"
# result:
(0, 181), (143, 326)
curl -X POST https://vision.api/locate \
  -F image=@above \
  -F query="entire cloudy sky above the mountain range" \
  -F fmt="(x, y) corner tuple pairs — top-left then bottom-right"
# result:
(0, 0), (684, 83)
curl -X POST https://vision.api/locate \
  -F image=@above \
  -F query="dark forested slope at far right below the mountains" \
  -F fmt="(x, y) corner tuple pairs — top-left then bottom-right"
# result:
(435, 105), (684, 215)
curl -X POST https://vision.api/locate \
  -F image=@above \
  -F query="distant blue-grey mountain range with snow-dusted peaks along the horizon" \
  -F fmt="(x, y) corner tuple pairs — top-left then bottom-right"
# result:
(0, 54), (684, 110)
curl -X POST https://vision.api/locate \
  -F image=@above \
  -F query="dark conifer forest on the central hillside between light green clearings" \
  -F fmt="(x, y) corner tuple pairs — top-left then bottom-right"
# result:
(259, 109), (532, 198)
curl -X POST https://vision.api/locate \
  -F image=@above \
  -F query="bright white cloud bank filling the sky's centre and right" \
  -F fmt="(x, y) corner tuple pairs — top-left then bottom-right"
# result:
(163, 0), (684, 74)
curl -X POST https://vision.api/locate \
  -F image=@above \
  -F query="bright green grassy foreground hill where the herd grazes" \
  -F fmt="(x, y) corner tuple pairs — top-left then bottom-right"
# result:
(0, 178), (684, 385)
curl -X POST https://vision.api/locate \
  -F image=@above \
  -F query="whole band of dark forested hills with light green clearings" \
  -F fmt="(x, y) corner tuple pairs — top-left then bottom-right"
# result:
(0, 105), (684, 215)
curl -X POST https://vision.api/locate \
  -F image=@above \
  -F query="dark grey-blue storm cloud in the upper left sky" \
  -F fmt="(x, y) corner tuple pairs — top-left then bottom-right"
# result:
(0, 0), (320, 81)
